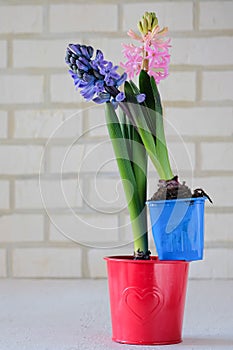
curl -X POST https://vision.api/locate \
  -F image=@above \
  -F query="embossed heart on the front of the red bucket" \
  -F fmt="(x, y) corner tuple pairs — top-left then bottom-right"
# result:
(123, 287), (163, 322)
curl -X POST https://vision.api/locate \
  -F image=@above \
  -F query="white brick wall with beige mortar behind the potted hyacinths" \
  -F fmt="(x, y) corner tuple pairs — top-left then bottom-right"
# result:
(0, 0), (233, 278)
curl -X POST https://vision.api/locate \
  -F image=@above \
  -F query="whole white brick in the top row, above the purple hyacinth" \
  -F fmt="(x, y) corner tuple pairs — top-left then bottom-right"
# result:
(50, 4), (117, 33)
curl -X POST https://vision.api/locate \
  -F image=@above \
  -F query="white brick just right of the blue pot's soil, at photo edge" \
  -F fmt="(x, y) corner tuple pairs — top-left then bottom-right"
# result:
(192, 176), (233, 207)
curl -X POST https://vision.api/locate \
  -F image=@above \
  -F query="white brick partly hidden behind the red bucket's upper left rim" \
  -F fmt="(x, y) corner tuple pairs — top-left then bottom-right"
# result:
(88, 245), (133, 278)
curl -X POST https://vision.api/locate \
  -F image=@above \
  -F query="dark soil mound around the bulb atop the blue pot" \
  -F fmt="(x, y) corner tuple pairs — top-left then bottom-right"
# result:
(150, 176), (212, 203)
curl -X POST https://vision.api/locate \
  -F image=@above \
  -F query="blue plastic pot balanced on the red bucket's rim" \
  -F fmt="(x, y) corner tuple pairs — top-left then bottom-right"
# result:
(146, 197), (206, 261)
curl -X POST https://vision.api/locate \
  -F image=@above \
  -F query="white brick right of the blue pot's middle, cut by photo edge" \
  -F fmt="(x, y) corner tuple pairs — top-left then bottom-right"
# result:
(205, 213), (233, 242)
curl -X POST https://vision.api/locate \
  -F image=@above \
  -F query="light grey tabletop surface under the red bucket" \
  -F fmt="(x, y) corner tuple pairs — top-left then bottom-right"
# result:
(0, 280), (233, 350)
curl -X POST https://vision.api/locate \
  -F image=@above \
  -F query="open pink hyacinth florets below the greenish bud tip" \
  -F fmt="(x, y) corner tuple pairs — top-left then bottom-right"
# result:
(121, 25), (170, 84)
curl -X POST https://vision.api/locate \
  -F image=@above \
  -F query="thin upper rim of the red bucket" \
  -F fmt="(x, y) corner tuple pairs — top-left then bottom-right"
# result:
(104, 255), (189, 265)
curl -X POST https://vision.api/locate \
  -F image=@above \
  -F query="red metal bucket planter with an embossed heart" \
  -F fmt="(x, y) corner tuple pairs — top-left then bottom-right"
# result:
(105, 256), (189, 345)
